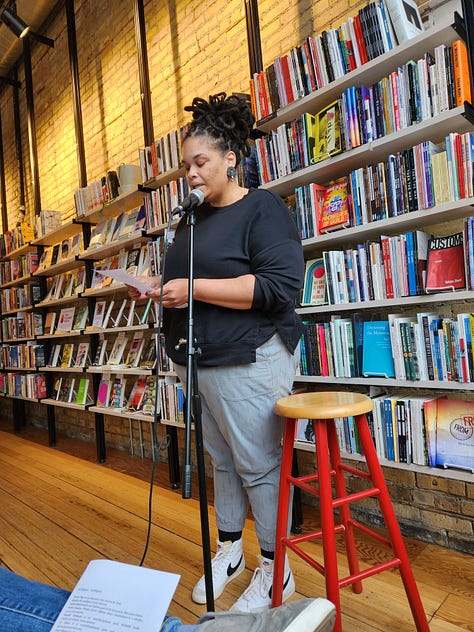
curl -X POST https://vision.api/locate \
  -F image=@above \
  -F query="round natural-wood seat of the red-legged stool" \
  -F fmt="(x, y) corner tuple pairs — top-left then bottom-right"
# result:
(275, 391), (374, 419)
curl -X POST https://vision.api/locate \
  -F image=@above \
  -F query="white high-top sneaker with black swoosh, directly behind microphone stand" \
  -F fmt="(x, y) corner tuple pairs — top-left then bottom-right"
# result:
(192, 538), (245, 603)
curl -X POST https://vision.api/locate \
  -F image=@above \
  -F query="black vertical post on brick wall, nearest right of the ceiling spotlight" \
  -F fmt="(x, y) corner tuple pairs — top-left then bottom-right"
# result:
(66, 0), (87, 187)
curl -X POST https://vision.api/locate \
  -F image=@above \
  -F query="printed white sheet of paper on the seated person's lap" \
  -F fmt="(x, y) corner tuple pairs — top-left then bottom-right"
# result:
(51, 560), (180, 632)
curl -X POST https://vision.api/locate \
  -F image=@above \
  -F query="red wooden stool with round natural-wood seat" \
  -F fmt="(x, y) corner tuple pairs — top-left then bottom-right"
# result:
(273, 392), (429, 632)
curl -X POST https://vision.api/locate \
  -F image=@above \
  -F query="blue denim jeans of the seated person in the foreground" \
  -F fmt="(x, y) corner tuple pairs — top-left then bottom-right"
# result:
(0, 567), (199, 632)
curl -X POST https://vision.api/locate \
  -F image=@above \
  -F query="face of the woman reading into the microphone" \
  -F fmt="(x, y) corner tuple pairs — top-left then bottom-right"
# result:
(182, 136), (235, 206)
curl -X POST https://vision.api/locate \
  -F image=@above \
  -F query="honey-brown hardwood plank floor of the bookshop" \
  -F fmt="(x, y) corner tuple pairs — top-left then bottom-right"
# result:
(0, 426), (474, 632)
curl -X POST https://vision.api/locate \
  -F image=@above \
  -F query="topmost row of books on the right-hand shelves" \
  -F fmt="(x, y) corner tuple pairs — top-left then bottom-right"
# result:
(250, 0), (423, 120)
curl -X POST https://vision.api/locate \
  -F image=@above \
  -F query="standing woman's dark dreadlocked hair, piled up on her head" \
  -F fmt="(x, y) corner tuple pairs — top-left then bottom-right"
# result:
(184, 92), (255, 164)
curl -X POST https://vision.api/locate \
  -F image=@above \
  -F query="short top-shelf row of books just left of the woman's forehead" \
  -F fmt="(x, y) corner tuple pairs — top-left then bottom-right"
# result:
(138, 125), (188, 182)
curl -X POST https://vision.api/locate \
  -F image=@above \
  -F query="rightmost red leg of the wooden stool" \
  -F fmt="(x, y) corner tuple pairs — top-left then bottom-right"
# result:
(355, 415), (429, 632)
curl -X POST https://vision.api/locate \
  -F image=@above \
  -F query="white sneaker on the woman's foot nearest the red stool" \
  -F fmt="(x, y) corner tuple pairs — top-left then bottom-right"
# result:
(230, 556), (295, 612)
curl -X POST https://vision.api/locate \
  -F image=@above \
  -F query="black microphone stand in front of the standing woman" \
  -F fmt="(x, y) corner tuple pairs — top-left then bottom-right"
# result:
(182, 207), (214, 612)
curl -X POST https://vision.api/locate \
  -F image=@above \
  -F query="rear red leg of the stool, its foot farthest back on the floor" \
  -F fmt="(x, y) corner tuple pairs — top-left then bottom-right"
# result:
(327, 419), (362, 594)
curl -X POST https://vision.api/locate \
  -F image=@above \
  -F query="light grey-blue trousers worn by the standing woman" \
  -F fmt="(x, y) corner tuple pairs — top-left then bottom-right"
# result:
(175, 334), (299, 551)
